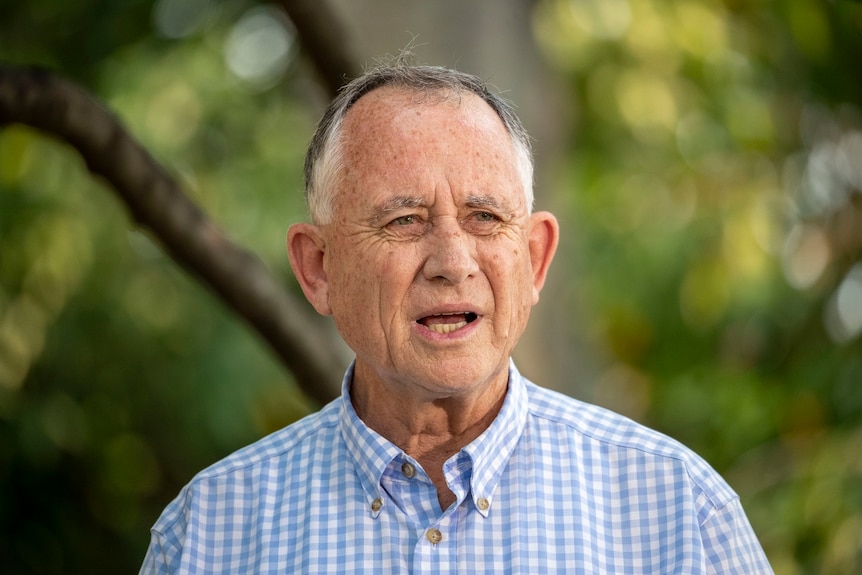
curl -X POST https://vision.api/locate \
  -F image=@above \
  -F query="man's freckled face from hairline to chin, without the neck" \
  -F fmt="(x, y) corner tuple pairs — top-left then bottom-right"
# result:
(294, 87), (556, 398)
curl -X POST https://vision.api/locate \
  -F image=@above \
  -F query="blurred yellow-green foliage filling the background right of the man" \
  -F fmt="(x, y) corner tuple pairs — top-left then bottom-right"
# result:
(533, 0), (862, 574)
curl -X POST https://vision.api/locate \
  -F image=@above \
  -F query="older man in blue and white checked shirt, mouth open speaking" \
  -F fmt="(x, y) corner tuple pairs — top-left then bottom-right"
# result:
(142, 64), (771, 575)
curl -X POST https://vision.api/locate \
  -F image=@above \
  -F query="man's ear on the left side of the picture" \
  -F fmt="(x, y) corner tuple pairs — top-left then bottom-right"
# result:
(287, 223), (332, 315)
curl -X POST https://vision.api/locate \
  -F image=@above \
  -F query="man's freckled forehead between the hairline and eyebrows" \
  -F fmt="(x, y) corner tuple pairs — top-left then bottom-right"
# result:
(339, 86), (524, 215)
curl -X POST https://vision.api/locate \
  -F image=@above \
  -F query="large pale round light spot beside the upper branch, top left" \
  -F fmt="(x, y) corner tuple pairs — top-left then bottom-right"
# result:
(224, 7), (296, 89)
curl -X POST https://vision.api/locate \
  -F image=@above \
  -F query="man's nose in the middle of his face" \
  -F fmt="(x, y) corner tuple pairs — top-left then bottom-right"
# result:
(422, 217), (479, 284)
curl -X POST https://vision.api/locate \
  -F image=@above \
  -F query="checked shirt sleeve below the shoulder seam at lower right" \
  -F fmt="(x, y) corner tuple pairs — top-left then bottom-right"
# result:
(701, 498), (773, 575)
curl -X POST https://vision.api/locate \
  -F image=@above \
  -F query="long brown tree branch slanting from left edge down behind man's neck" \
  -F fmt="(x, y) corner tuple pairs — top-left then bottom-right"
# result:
(0, 66), (343, 403)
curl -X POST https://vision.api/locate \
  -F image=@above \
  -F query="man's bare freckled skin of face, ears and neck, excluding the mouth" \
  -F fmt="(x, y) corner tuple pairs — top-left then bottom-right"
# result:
(288, 87), (558, 504)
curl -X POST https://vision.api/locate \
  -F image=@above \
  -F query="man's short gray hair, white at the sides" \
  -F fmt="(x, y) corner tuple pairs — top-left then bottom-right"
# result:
(305, 59), (533, 224)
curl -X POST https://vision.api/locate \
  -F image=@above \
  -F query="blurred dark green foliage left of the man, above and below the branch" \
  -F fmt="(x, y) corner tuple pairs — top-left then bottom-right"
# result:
(0, 1), (314, 574)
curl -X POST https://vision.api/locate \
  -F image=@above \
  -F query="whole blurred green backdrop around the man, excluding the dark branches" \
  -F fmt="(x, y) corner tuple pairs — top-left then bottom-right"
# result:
(0, 0), (862, 575)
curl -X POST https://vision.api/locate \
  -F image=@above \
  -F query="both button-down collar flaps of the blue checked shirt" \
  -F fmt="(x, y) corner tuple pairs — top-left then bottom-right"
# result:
(339, 360), (528, 516)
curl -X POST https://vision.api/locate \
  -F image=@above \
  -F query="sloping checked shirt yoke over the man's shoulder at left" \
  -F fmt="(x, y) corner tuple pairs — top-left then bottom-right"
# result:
(192, 400), (339, 483)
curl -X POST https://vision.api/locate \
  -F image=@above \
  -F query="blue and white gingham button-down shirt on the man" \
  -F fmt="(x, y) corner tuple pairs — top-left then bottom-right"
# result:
(141, 364), (772, 575)
